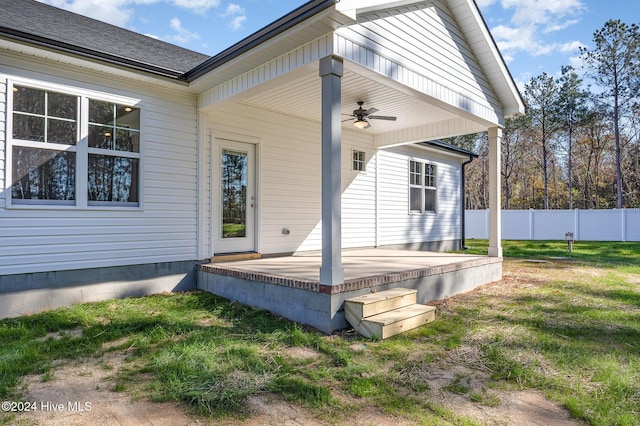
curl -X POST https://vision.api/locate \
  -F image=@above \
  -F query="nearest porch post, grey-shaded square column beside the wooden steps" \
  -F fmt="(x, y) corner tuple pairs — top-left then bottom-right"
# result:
(320, 56), (344, 285)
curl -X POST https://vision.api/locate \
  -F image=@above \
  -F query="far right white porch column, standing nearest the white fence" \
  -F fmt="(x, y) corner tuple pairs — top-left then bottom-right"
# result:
(488, 127), (502, 257)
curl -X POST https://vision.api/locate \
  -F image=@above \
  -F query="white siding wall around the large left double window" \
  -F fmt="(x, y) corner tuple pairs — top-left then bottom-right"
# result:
(0, 55), (197, 274)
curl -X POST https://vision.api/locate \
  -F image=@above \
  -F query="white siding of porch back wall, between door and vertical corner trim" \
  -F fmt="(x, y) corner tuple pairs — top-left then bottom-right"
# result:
(207, 105), (375, 254)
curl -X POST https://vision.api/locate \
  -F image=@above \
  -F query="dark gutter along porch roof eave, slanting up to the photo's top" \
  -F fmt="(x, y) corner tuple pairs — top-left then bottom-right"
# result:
(182, 0), (340, 83)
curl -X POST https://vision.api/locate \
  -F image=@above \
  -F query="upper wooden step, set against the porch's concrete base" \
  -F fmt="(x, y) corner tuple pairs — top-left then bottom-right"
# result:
(344, 288), (418, 325)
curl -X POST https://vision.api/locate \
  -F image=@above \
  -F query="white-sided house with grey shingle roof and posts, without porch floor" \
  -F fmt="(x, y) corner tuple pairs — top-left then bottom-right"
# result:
(0, 0), (524, 330)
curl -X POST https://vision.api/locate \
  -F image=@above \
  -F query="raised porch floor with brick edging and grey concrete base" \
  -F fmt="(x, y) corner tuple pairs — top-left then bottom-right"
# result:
(198, 248), (502, 334)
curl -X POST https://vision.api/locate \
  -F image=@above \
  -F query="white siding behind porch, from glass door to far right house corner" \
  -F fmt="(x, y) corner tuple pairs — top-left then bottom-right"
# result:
(207, 105), (462, 254)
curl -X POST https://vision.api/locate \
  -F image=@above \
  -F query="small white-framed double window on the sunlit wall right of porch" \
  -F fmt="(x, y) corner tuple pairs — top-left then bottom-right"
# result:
(409, 160), (438, 213)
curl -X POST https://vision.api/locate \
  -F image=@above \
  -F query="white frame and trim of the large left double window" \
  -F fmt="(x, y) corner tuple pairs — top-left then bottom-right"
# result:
(4, 78), (145, 211)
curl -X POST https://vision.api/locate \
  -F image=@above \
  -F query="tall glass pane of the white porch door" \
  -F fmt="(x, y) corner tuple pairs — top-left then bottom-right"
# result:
(222, 149), (248, 238)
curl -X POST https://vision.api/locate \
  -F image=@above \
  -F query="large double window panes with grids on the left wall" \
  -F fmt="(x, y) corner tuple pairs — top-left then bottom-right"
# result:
(11, 84), (140, 207)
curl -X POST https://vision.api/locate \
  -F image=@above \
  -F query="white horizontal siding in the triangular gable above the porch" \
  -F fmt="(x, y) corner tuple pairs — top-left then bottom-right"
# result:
(336, 0), (502, 120)
